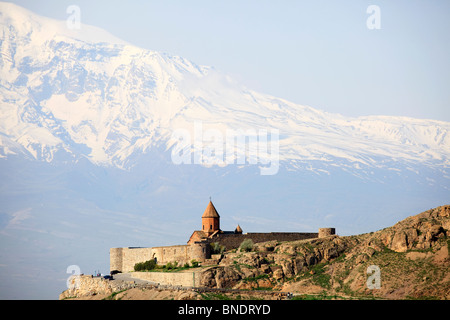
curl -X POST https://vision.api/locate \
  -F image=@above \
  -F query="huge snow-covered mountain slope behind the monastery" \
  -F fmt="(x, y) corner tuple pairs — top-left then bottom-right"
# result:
(0, 3), (450, 174)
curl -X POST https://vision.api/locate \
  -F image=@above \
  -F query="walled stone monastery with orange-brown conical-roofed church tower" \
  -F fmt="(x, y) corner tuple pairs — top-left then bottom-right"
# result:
(110, 201), (335, 272)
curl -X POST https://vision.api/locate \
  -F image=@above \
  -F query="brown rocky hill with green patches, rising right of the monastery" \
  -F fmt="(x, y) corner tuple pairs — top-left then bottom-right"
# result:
(63, 205), (450, 299)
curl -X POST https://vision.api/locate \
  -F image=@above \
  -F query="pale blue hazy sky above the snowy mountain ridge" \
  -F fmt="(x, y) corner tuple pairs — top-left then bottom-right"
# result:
(6, 0), (450, 121)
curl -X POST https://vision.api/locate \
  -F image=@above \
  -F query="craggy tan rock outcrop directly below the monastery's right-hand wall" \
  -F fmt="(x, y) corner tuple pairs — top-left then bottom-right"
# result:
(200, 235), (352, 288)
